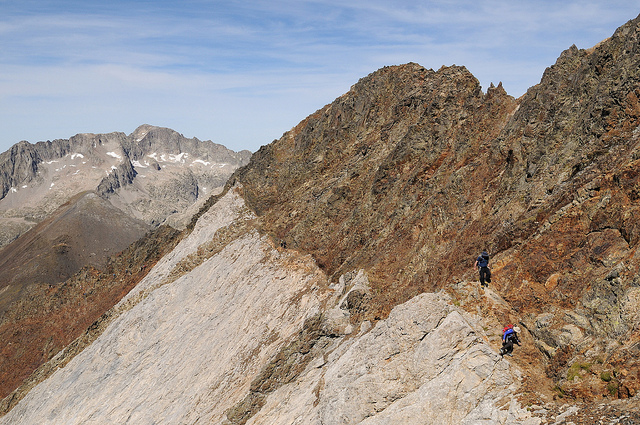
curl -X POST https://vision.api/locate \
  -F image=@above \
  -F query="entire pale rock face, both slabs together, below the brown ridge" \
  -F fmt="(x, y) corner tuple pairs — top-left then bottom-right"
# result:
(0, 190), (539, 425)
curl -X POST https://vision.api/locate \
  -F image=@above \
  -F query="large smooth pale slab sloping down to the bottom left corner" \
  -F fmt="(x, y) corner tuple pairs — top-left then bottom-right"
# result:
(0, 190), (329, 424)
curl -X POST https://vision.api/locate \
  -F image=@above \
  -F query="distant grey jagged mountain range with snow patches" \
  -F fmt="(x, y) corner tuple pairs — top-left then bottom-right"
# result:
(0, 125), (251, 246)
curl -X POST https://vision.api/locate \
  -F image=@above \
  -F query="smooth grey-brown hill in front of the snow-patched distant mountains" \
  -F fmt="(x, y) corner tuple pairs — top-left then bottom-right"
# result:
(0, 192), (149, 312)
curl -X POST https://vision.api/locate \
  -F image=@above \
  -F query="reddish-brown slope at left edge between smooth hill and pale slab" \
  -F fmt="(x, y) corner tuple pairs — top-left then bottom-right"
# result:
(0, 226), (181, 400)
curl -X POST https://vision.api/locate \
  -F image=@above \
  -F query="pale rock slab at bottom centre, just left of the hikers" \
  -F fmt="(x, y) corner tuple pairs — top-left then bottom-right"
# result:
(247, 294), (539, 425)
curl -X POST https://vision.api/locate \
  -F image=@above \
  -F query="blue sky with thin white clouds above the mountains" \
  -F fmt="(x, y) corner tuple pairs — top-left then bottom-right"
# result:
(0, 0), (640, 152)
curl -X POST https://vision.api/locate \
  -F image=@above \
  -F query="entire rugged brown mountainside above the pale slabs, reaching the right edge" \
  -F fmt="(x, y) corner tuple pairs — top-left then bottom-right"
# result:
(234, 18), (640, 399)
